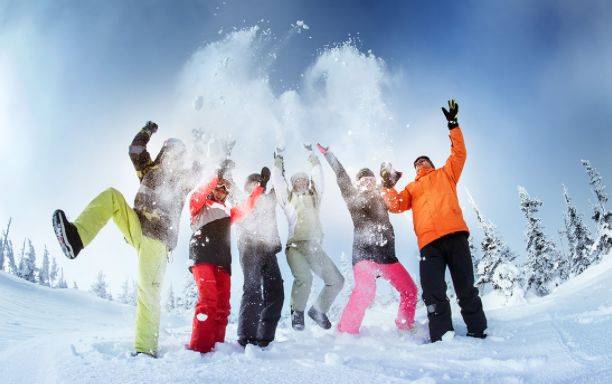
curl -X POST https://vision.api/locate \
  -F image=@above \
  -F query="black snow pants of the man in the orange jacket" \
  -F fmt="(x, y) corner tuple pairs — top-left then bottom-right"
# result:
(419, 232), (487, 342)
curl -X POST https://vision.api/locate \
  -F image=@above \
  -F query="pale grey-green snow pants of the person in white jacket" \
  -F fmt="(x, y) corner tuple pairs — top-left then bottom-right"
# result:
(286, 241), (344, 313)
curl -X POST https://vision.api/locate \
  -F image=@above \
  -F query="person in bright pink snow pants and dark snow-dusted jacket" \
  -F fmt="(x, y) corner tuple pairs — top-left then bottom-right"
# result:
(317, 144), (417, 333)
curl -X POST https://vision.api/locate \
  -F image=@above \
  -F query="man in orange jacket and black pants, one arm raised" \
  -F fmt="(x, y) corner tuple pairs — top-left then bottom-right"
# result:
(381, 100), (487, 342)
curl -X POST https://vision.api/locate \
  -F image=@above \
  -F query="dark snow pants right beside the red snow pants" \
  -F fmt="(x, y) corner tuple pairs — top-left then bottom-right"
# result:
(238, 241), (285, 343)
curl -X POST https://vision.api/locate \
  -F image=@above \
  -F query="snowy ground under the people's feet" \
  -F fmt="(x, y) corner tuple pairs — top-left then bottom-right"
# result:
(0, 257), (612, 384)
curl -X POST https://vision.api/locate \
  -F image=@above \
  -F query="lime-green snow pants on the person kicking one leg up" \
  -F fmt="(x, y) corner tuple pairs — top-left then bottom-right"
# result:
(74, 188), (168, 355)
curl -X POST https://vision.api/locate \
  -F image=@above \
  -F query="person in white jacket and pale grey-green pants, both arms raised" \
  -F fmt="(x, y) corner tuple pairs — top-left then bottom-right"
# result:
(271, 145), (344, 331)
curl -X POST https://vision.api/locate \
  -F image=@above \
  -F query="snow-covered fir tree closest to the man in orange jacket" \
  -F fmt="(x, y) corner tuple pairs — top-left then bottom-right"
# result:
(468, 192), (522, 299)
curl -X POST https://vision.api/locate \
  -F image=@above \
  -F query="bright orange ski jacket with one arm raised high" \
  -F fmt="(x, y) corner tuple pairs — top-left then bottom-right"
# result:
(383, 127), (469, 249)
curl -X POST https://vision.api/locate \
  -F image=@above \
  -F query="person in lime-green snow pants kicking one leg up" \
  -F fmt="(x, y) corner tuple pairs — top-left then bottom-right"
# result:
(53, 122), (200, 357)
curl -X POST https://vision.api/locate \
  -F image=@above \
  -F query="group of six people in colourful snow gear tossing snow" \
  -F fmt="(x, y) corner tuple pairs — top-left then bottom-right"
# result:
(53, 100), (487, 357)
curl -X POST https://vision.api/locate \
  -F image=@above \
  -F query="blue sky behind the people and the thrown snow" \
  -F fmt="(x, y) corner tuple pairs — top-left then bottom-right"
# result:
(0, 0), (612, 294)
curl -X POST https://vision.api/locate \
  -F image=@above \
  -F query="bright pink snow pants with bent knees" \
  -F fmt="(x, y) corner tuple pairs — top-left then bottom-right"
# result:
(338, 260), (417, 333)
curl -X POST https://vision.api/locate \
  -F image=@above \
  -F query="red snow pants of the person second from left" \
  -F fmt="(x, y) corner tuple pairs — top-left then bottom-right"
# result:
(189, 264), (231, 353)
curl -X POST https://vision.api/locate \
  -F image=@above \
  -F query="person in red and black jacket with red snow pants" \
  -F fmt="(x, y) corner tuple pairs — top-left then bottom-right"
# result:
(189, 161), (267, 353)
